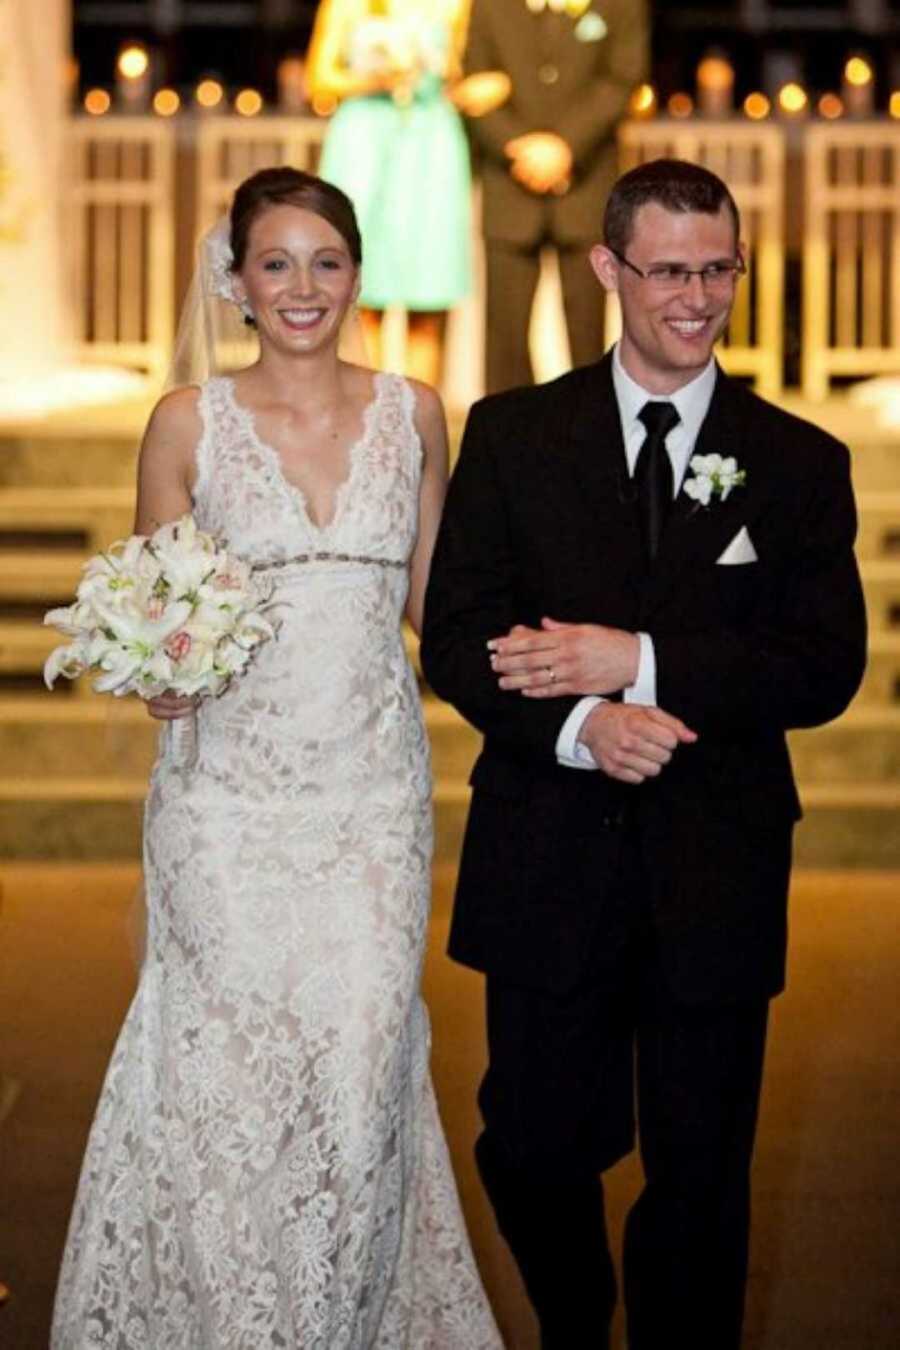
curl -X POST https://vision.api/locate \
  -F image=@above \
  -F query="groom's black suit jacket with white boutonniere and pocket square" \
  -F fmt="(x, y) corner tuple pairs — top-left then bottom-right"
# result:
(421, 356), (865, 1002)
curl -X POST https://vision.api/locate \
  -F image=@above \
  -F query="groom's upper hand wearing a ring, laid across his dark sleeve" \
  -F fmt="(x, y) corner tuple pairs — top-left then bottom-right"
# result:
(487, 618), (641, 698)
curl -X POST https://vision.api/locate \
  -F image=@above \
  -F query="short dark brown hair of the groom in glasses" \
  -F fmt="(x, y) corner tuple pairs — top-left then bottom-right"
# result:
(603, 159), (741, 254)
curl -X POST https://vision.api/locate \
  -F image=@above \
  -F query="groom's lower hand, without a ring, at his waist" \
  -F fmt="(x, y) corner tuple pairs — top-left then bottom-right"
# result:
(578, 703), (698, 783)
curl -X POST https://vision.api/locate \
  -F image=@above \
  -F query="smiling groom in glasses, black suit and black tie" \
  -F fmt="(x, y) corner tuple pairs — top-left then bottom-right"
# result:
(422, 161), (865, 1350)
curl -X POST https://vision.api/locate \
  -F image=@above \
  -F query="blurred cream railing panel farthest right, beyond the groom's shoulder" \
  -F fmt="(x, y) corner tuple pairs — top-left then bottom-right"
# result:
(803, 122), (900, 400)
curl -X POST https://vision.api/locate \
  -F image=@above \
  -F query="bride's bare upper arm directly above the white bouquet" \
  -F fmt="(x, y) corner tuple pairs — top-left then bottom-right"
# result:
(135, 386), (202, 535)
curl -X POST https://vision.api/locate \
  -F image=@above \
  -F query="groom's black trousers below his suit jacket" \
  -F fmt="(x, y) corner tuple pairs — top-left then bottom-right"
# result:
(476, 853), (768, 1350)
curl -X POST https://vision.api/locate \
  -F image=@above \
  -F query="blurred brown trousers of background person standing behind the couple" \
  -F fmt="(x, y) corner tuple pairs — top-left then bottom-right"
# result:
(486, 239), (603, 394)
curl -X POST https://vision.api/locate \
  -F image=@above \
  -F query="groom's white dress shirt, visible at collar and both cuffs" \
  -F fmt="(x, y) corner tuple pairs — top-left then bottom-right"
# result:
(556, 343), (716, 768)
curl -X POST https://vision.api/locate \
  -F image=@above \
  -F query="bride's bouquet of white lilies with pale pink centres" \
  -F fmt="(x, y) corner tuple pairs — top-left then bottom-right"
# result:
(43, 516), (275, 764)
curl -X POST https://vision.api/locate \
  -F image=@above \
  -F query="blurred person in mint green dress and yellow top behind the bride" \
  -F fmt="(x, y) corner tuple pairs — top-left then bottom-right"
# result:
(308, 0), (471, 385)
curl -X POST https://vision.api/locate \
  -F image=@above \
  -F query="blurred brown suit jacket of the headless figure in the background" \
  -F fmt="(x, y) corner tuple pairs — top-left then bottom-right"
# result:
(463, 0), (649, 246)
